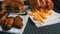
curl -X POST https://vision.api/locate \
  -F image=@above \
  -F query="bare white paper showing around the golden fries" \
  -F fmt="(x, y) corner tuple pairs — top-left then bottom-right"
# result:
(30, 10), (60, 27)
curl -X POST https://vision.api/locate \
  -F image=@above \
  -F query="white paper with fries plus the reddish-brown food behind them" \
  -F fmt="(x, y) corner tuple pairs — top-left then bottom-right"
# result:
(27, 0), (60, 27)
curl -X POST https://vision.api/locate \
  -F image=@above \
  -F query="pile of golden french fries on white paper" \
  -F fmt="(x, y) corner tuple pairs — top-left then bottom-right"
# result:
(30, 9), (52, 24)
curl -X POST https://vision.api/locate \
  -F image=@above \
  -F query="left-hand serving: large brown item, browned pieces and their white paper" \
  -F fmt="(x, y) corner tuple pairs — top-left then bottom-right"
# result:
(0, 0), (28, 34)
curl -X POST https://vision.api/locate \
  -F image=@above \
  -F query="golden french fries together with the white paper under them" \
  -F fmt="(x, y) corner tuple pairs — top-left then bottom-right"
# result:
(29, 10), (60, 27)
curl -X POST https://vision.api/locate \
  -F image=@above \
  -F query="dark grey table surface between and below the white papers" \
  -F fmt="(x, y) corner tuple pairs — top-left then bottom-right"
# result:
(0, 0), (60, 34)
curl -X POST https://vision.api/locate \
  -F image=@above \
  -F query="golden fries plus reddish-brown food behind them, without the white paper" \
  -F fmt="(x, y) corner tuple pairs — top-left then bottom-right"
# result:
(27, 0), (54, 24)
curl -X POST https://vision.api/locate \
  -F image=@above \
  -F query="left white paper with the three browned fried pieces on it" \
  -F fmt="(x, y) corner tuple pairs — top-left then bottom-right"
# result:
(0, 12), (28, 34)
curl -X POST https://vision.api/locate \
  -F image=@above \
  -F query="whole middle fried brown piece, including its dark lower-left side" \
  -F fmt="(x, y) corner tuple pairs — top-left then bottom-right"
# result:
(2, 17), (14, 30)
